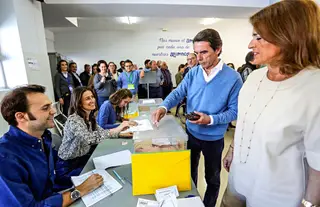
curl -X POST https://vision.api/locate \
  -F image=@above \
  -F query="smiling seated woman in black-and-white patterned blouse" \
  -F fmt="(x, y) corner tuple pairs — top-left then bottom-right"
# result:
(56, 87), (132, 187)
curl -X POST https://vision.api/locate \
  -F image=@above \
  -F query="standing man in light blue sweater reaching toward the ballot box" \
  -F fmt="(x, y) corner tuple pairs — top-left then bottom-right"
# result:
(153, 29), (242, 207)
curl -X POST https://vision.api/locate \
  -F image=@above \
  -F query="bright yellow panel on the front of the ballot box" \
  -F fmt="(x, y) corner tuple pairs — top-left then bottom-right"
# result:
(131, 150), (191, 195)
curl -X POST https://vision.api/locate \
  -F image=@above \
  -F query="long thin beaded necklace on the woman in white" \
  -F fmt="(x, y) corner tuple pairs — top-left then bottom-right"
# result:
(240, 72), (281, 164)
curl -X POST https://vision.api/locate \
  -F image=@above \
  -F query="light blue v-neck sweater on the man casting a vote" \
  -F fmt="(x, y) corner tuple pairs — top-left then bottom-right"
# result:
(162, 64), (242, 141)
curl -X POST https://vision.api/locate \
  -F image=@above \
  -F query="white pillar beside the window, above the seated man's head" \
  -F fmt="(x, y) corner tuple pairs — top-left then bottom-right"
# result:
(14, 0), (54, 100)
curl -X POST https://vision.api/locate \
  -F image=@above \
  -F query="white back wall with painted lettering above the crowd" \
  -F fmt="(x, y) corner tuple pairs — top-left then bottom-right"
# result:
(55, 19), (252, 84)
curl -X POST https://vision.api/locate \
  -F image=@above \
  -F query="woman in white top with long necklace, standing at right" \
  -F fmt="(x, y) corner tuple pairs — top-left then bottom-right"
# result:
(221, 0), (320, 207)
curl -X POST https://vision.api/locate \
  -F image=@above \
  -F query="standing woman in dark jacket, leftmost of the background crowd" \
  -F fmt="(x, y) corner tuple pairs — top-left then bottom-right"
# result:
(54, 60), (74, 115)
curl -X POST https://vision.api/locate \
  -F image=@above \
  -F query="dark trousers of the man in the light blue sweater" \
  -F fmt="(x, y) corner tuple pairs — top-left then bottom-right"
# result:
(187, 131), (224, 207)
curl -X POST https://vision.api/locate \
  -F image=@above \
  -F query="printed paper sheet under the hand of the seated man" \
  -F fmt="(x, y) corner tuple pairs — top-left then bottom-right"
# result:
(71, 170), (122, 207)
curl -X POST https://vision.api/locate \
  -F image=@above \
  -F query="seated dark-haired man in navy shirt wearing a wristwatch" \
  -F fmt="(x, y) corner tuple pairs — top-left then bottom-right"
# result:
(0, 85), (103, 207)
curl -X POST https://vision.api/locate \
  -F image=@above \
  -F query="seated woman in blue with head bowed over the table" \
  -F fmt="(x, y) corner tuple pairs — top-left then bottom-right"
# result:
(97, 88), (137, 129)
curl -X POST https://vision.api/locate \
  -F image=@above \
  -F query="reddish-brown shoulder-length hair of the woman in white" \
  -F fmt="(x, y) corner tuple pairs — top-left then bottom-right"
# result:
(250, 0), (320, 75)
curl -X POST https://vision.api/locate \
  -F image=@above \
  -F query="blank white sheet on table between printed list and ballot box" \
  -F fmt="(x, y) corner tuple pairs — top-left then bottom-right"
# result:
(93, 150), (131, 170)
